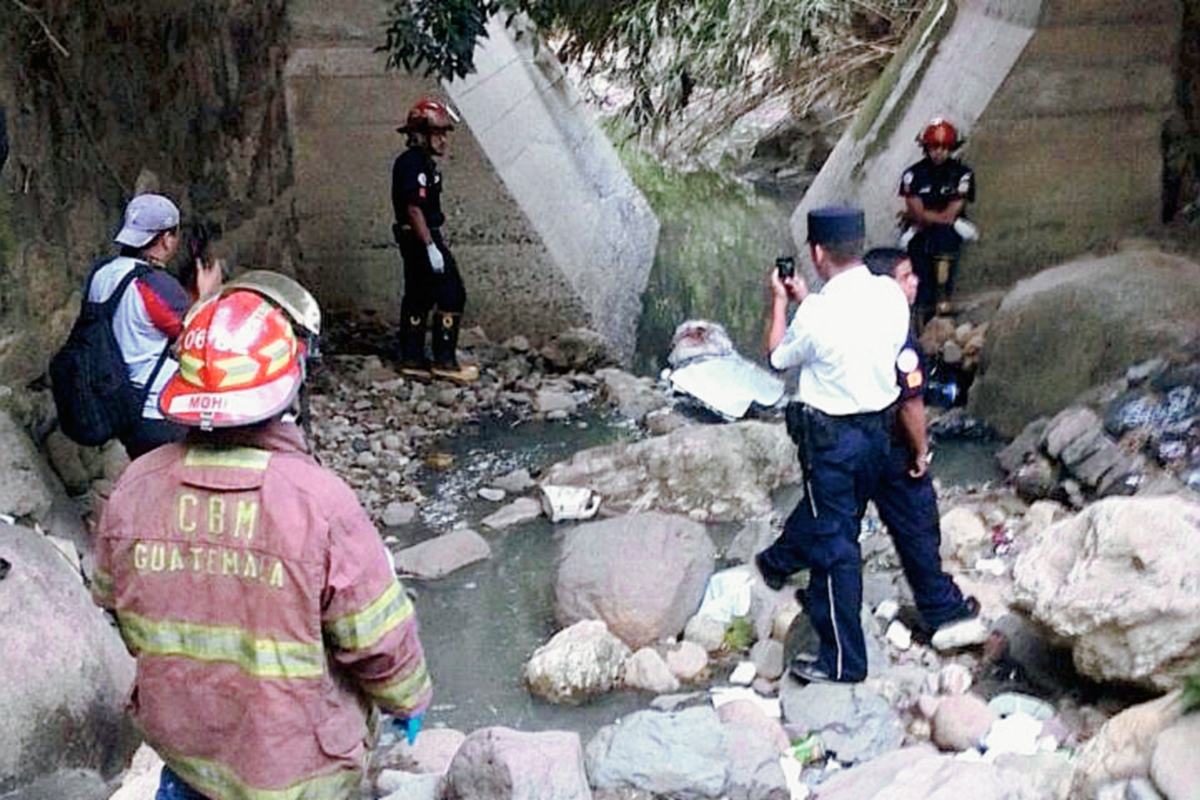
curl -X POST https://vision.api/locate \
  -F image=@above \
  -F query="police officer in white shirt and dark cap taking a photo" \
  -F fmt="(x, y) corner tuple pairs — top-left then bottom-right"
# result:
(755, 206), (908, 682)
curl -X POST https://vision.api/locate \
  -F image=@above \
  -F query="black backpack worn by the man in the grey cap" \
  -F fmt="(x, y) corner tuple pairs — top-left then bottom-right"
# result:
(50, 260), (170, 446)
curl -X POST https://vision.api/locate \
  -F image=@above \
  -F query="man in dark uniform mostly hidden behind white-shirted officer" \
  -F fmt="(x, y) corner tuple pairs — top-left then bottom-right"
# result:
(863, 247), (988, 646)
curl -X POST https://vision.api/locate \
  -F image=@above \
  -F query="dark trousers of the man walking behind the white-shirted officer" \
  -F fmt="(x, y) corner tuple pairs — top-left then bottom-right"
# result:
(872, 441), (970, 628)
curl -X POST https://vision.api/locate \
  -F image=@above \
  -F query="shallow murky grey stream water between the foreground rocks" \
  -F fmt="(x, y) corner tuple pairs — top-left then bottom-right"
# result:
(404, 407), (995, 741)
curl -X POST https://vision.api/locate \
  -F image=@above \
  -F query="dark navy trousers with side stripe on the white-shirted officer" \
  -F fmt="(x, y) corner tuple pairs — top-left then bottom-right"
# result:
(758, 411), (893, 681)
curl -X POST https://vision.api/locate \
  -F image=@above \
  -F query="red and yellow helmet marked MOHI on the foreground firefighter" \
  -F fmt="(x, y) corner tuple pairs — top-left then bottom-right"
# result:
(158, 290), (304, 429)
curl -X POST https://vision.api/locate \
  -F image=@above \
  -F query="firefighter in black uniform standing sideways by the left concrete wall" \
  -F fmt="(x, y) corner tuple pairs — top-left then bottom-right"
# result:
(391, 97), (478, 379)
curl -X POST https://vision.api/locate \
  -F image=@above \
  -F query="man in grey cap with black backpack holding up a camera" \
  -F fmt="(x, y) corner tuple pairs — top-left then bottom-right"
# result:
(50, 193), (222, 458)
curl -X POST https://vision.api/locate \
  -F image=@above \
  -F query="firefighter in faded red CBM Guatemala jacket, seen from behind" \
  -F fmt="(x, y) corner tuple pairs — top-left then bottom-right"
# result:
(92, 277), (432, 800)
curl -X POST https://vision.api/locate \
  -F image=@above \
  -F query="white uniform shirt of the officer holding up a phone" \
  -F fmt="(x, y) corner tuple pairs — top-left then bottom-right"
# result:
(770, 265), (908, 416)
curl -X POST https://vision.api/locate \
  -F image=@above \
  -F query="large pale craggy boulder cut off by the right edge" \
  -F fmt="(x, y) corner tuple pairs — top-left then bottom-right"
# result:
(1013, 495), (1200, 690)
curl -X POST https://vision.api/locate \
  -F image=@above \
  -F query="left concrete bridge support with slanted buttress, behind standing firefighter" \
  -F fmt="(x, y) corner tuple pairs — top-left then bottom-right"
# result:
(280, 0), (658, 359)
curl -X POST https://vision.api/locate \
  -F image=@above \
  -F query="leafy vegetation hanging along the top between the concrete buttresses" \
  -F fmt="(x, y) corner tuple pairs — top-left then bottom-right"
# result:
(379, 0), (929, 139)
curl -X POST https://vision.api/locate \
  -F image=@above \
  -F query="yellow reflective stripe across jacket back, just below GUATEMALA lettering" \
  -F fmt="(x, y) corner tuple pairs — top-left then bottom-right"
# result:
(120, 613), (325, 680)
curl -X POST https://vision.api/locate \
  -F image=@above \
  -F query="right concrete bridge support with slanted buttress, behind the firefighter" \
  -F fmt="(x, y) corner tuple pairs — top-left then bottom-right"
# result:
(792, 0), (1180, 291)
